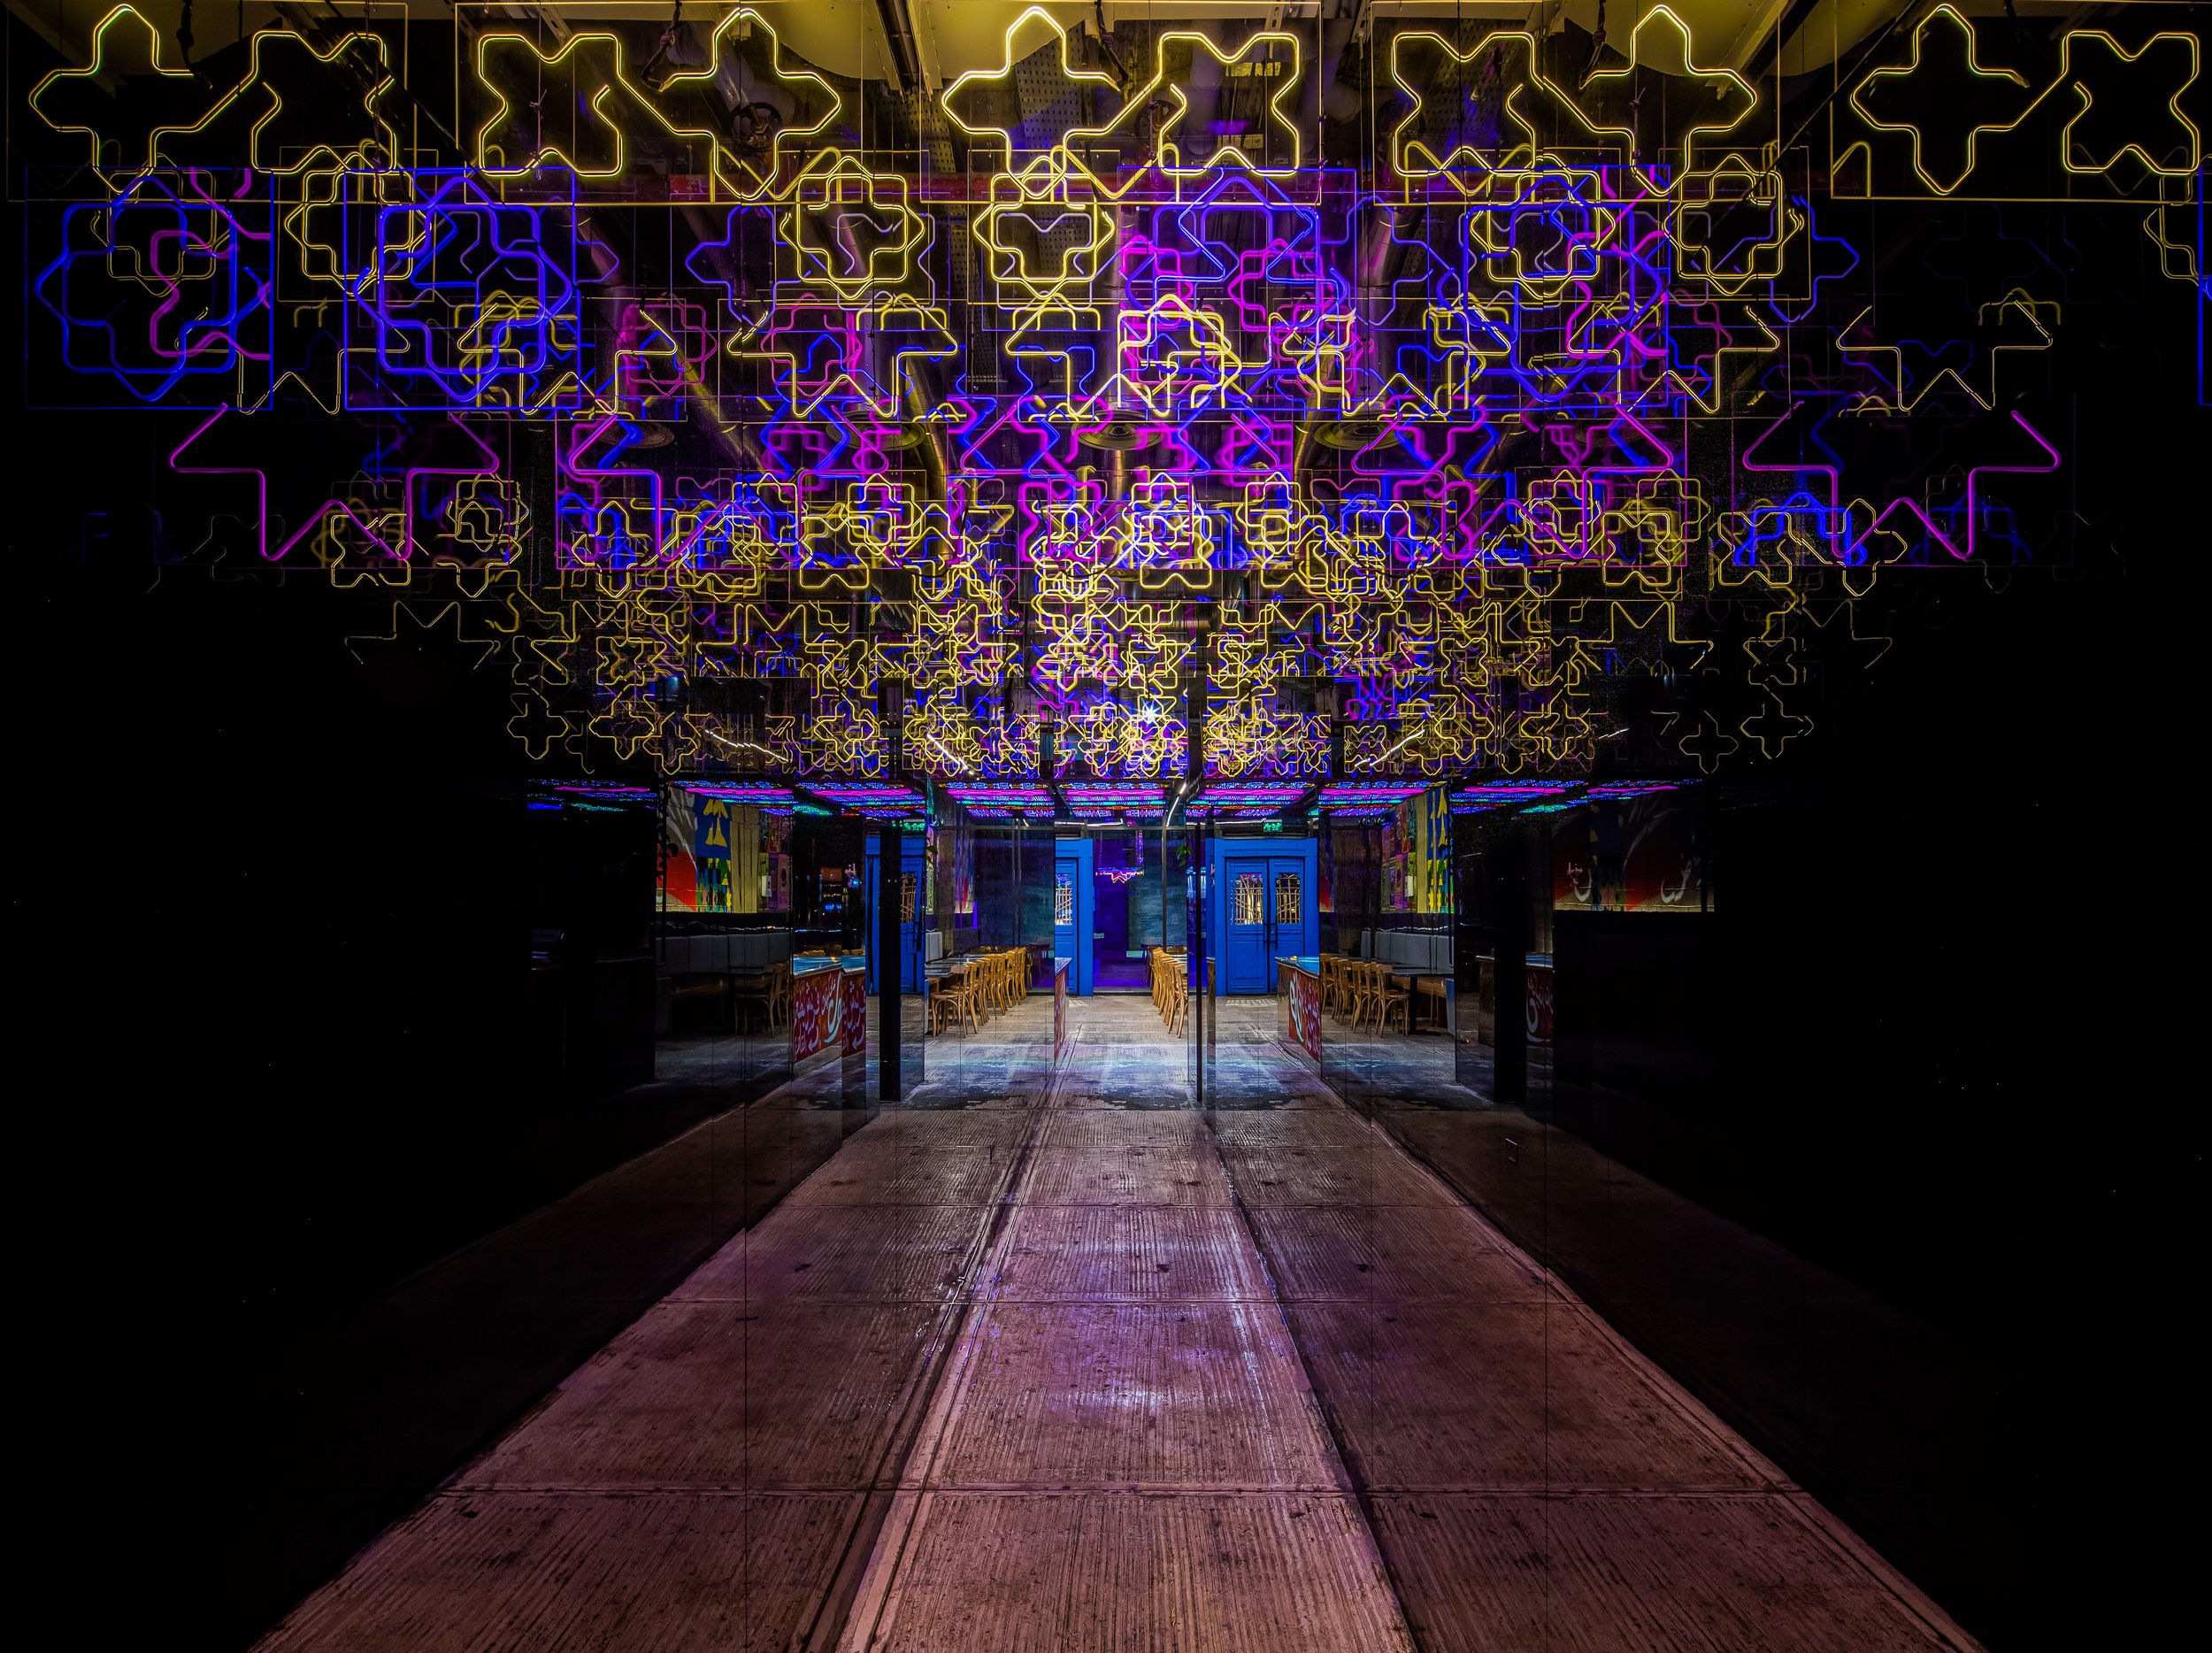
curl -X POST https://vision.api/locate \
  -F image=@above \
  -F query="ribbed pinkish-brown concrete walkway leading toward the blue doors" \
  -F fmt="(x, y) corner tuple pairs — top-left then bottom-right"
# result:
(250, 998), (1973, 1653)
